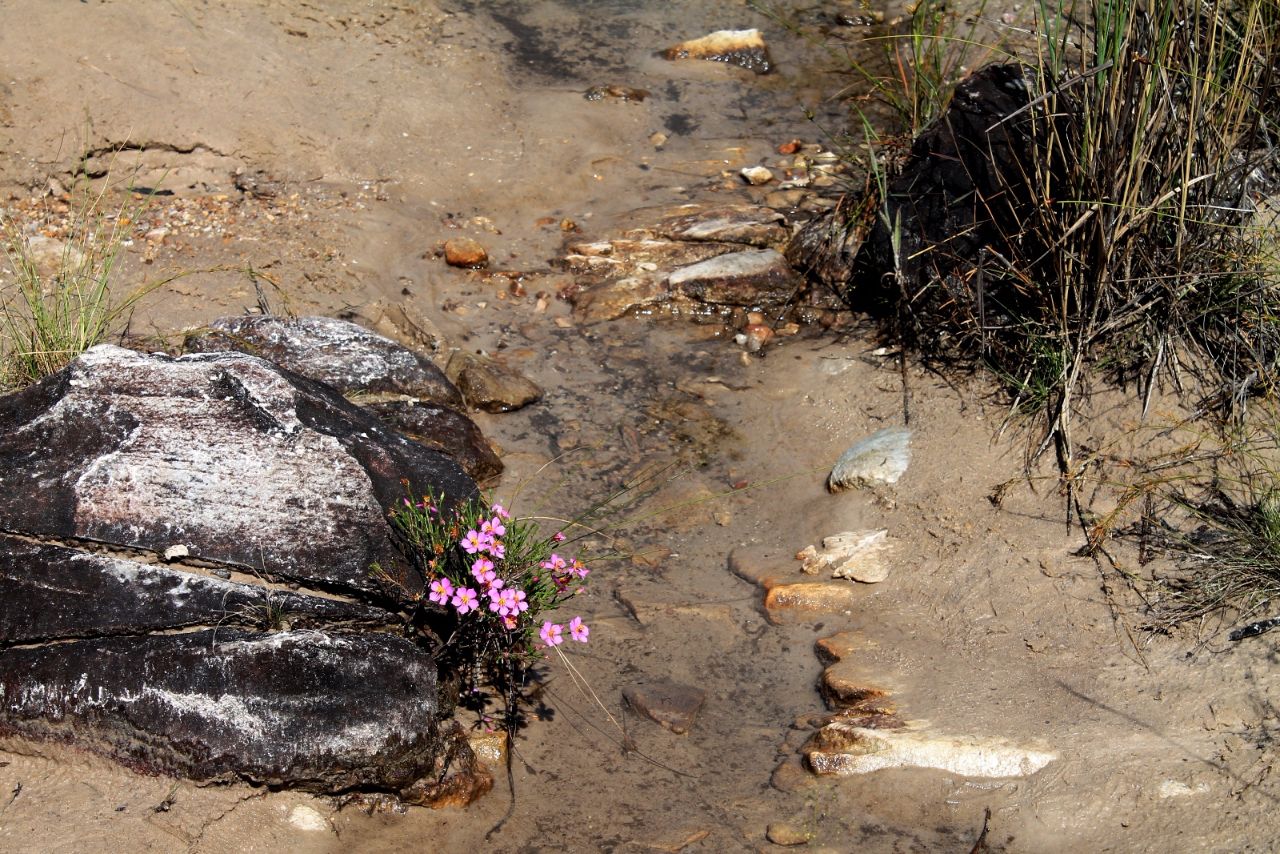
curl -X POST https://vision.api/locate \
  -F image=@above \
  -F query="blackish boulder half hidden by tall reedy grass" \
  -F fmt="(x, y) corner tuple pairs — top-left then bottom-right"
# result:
(787, 64), (1046, 312)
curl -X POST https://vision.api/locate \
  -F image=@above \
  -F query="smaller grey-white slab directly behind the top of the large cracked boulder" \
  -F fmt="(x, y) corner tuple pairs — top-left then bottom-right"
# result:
(186, 315), (462, 407)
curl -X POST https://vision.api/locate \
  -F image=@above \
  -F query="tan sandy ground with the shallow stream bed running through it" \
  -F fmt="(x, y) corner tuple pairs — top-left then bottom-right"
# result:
(0, 0), (1280, 851)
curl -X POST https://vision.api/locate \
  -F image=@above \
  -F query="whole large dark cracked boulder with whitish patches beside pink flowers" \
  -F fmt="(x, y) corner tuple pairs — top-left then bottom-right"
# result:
(0, 346), (490, 803)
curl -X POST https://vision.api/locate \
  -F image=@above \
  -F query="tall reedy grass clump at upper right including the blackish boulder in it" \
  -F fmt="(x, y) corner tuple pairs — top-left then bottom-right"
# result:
(801, 0), (1280, 475)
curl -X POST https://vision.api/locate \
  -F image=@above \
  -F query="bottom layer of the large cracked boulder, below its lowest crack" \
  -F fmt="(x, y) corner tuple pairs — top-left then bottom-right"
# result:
(0, 629), (481, 791)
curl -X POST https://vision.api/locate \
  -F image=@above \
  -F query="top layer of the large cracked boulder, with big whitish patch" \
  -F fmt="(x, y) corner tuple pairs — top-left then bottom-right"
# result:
(0, 346), (475, 593)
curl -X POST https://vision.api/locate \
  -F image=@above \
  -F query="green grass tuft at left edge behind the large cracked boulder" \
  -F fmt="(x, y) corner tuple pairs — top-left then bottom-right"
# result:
(0, 184), (164, 391)
